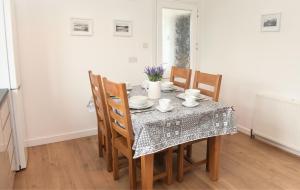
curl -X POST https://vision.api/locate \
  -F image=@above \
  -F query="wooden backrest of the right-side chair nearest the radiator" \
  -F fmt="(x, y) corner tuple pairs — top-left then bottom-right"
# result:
(193, 71), (222, 102)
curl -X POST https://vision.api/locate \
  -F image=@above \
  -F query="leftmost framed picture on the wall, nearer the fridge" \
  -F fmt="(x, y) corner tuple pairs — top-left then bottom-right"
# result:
(71, 18), (93, 36)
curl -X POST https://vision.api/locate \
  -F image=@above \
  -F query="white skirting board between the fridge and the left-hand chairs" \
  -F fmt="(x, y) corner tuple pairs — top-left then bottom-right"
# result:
(26, 128), (97, 147)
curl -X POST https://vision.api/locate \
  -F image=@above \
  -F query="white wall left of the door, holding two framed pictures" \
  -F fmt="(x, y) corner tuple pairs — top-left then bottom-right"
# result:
(15, 0), (154, 145)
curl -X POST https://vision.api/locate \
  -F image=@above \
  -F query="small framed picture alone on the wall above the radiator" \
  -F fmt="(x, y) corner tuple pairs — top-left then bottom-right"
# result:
(261, 13), (281, 32)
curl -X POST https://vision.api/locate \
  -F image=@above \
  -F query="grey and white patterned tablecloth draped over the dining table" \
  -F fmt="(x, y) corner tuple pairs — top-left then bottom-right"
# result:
(130, 86), (237, 158)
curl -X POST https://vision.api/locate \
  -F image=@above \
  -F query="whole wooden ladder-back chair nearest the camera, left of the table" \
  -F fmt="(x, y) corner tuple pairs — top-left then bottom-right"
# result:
(103, 78), (172, 189)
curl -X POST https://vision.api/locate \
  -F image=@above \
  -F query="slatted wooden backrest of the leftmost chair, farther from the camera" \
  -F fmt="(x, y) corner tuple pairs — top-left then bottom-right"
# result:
(89, 71), (111, 137)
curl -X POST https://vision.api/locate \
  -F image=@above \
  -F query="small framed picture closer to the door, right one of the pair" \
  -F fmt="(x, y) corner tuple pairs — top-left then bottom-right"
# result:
(113, 20), (132, 37)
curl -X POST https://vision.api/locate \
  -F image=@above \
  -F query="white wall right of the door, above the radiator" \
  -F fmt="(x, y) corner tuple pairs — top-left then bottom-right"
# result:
(199, 0), (300, 128)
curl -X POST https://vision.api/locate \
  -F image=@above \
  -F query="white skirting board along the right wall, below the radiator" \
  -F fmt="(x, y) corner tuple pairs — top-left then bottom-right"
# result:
(238, 125), (300, 156)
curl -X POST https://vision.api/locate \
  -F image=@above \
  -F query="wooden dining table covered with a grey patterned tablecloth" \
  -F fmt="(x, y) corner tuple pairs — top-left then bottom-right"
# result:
(129, 86), (237, 190)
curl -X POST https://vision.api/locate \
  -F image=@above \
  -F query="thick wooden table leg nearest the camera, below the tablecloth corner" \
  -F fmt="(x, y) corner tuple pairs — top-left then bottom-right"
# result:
(141, 154), (154, 190)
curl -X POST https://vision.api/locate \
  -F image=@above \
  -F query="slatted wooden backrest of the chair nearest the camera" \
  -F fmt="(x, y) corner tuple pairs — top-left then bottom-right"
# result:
(103, 78), (133, 148)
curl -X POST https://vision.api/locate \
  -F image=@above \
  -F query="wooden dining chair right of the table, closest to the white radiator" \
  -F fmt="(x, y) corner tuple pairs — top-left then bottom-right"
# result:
(177, 71), (222, 182)
